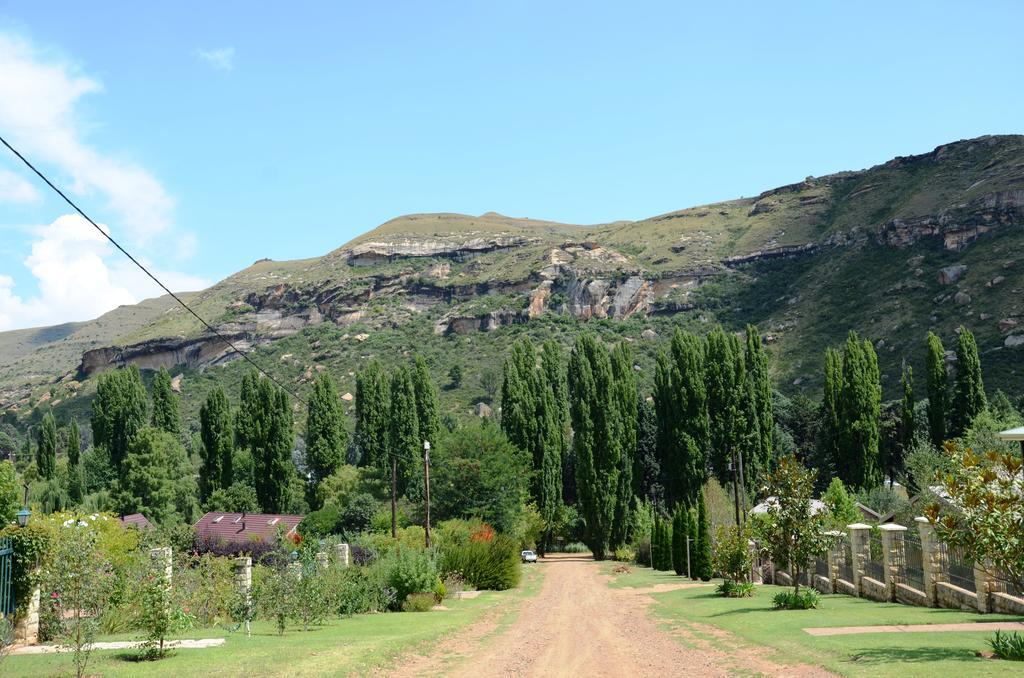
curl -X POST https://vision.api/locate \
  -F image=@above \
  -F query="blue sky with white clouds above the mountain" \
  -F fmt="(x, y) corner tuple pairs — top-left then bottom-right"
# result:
(0, 0), (1024, 330)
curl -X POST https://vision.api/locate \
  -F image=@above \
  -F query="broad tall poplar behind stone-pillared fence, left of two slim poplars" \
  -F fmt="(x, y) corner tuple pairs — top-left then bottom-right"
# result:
(836, 331), (882, 490)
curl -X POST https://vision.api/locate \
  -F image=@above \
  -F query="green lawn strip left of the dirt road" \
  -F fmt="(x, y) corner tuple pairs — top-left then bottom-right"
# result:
(6, 567), (542, 678)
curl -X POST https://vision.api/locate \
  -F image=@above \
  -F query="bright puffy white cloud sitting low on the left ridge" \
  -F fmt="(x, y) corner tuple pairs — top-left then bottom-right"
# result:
(0, 214), (209, 331)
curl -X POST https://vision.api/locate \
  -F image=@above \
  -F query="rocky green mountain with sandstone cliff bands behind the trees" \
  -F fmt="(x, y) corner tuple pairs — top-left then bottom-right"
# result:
(0, 135), (1024, 426)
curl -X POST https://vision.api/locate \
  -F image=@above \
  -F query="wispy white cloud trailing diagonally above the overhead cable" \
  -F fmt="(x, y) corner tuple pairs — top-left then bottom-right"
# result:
(0, 35), (174, 244)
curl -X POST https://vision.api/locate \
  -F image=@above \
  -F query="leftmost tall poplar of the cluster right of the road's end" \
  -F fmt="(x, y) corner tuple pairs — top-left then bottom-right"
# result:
(654, 330), (709, 506)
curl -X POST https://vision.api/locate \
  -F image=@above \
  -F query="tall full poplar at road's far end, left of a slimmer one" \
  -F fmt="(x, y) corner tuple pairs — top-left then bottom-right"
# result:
(568, 333), (622, 560)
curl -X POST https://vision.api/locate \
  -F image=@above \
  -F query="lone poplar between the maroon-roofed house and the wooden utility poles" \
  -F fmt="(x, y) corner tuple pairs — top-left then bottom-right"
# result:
(306, 372), (348, 497)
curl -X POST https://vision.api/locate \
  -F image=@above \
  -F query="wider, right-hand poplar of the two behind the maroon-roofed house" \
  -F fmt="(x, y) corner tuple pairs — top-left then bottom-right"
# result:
(234, 370), (295, 513)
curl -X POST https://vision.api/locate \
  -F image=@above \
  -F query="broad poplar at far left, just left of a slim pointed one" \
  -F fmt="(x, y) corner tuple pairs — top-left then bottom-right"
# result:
(91, 365), (148, 473)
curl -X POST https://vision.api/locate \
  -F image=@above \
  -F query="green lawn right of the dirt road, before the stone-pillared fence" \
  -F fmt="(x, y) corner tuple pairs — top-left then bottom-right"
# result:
(605, 565), (1024, 678)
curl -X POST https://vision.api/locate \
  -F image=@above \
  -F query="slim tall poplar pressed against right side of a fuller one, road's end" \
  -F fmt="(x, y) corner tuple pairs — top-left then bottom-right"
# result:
(611, 342), (637, 548)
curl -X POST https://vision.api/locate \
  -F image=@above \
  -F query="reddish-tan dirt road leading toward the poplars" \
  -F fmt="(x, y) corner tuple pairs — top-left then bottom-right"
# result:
(393, 554), (828, 678)
